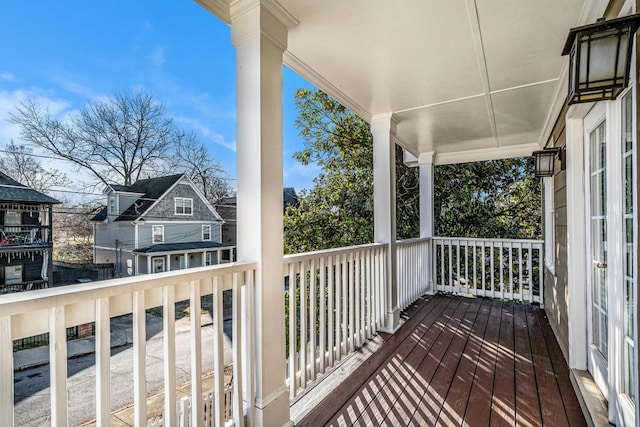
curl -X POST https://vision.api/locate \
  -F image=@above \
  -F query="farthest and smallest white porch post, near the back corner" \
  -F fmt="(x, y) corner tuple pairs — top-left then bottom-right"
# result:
(418, 151), (435, 295)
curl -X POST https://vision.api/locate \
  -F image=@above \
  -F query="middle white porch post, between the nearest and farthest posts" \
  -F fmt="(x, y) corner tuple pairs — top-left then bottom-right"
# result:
(371, 114), (400, 333)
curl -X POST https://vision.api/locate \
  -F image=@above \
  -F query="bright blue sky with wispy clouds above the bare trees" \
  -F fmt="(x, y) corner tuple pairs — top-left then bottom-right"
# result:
(0, 0), (317, 201)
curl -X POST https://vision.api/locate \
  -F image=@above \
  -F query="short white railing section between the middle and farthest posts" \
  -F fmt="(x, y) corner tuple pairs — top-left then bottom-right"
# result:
(396, 238), (431, 310)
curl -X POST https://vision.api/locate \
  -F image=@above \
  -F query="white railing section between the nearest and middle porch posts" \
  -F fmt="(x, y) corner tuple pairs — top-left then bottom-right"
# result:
(284, 244), (388, 399)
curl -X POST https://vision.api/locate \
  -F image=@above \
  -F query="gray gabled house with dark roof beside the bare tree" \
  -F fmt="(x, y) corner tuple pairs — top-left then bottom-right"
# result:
(91, 174), (232, 277)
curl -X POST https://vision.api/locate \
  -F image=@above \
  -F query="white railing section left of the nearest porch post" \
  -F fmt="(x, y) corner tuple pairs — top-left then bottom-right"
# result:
(0, 263), (256, 426)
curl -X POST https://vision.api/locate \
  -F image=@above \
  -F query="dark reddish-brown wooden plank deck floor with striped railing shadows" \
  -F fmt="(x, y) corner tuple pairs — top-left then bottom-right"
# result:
(296, 296), (586, 426)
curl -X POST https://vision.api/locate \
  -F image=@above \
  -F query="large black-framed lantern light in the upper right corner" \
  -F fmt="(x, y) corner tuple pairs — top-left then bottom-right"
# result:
(562, 14), (640, 104)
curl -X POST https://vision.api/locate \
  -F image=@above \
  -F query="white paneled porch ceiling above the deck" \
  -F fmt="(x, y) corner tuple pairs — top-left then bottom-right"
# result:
(197, 0), (607, 163)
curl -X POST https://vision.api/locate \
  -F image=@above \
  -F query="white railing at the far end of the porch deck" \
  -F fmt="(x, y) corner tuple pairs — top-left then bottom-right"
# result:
(432, 237), (544, 305)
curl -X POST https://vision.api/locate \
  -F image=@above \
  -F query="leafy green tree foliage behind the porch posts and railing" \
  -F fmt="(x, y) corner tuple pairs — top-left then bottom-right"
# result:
(284, 89), (540, 253)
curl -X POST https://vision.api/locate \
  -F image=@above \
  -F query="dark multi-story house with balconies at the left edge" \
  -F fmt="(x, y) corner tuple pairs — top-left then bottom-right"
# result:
(0, 172), (60, 294)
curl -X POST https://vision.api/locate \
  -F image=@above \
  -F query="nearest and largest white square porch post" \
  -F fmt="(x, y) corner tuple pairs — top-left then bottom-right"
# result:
(230, 0), (296, 426)
